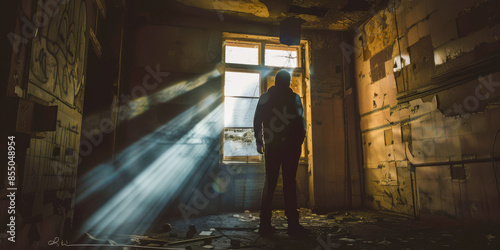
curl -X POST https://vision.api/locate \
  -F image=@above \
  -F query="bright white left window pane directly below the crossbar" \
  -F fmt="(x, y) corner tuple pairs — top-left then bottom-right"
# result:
(224, 71), (260, 97)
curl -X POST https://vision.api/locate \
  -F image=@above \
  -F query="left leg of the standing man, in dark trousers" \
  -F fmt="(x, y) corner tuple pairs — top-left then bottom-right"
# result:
(260, 147), (281, 233)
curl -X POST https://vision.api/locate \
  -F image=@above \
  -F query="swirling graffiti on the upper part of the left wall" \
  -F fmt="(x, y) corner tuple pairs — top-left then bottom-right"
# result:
(30, 0), (87, 110)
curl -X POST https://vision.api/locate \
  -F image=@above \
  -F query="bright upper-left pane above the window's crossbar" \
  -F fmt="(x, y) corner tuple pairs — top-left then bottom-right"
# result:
(226, 44), (259, 65)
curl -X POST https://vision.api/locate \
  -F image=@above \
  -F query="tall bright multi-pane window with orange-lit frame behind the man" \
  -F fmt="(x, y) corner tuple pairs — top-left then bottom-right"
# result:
(222, 36), (305, 162)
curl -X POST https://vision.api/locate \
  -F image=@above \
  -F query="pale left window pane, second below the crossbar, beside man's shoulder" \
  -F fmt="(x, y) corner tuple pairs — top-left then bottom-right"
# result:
(224, 97), (259, 128)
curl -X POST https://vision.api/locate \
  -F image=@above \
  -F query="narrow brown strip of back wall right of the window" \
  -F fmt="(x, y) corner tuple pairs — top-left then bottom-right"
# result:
(304, 31), (350, 210)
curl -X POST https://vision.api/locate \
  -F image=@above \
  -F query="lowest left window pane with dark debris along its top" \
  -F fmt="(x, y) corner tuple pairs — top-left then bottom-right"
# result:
(224, 129), (259, 156)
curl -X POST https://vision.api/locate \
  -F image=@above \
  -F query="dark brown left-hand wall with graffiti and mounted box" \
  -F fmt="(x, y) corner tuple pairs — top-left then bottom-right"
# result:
(2, 0), (95, 249)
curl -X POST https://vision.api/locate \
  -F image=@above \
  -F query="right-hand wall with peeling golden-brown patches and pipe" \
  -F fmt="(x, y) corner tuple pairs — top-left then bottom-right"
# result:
(349, 0), (500, 220)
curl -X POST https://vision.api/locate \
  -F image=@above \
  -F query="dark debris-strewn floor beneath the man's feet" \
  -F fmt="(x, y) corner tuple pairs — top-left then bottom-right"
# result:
(84, 209), (500, 250)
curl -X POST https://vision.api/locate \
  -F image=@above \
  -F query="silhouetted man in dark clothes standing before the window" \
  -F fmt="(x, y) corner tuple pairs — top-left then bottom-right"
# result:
(254, 70), (307, 237)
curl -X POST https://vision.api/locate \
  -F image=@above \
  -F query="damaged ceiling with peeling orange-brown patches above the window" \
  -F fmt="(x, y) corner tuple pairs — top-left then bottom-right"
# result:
(170, 0), (386, 30)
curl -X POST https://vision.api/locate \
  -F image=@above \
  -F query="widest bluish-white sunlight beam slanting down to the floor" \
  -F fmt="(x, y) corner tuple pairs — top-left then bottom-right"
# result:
(82, 104), (223, 235)
